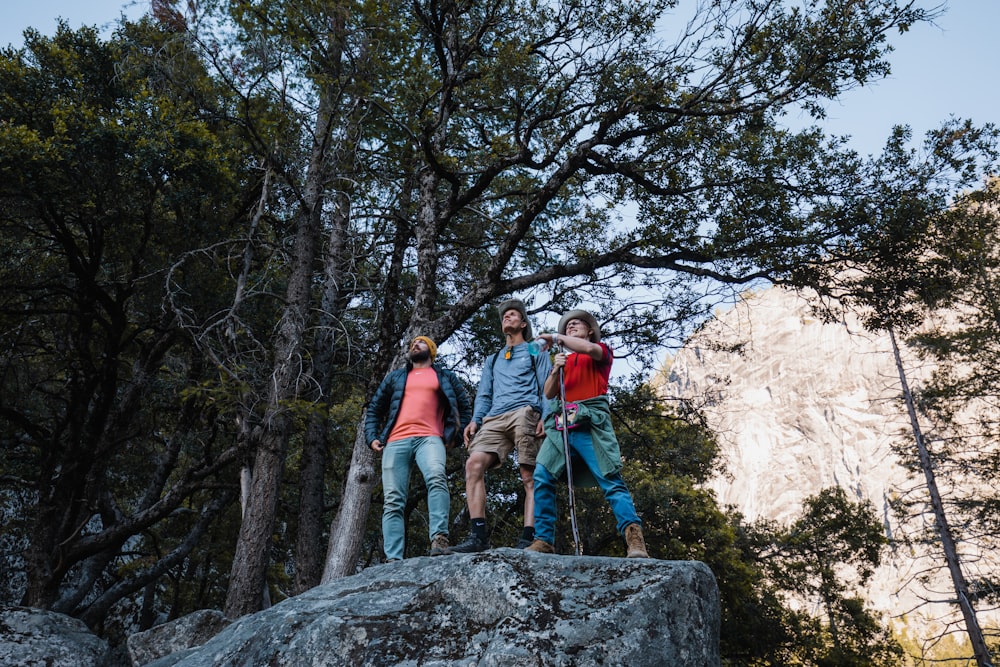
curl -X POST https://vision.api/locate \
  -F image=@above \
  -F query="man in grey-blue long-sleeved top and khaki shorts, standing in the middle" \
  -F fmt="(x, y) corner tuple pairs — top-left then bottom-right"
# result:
(449, 299), (552, 553)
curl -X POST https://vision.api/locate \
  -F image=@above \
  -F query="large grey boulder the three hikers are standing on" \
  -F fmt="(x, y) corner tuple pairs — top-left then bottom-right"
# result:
(151, 549), (720, 667)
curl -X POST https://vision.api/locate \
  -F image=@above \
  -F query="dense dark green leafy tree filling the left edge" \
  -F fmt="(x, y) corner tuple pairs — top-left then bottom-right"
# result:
(0, 19), (258, 627)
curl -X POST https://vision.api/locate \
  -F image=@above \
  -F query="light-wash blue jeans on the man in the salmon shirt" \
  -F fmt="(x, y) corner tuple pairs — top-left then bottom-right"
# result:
(382, 436), (451, 559)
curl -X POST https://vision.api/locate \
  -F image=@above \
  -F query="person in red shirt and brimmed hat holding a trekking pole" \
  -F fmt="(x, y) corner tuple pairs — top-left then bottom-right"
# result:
(527, 310), (649, 558)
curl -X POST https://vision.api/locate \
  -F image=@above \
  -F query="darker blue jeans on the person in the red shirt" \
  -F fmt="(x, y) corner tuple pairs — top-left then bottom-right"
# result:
(535, 428), (642, 544)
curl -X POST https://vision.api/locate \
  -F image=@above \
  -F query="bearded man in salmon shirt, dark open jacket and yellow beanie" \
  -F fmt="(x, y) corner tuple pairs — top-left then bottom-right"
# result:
(365, 336), (472, 561)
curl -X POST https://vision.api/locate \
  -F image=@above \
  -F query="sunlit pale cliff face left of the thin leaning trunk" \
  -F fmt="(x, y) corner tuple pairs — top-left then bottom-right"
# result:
(655, 288), (985, 636)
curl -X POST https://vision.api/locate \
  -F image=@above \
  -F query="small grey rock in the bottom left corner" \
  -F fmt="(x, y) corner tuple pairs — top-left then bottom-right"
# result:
(0, 607), (111, 667)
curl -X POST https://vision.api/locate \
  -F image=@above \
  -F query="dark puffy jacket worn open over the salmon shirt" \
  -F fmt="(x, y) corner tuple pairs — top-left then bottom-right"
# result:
(365, 364), (472, 447)
